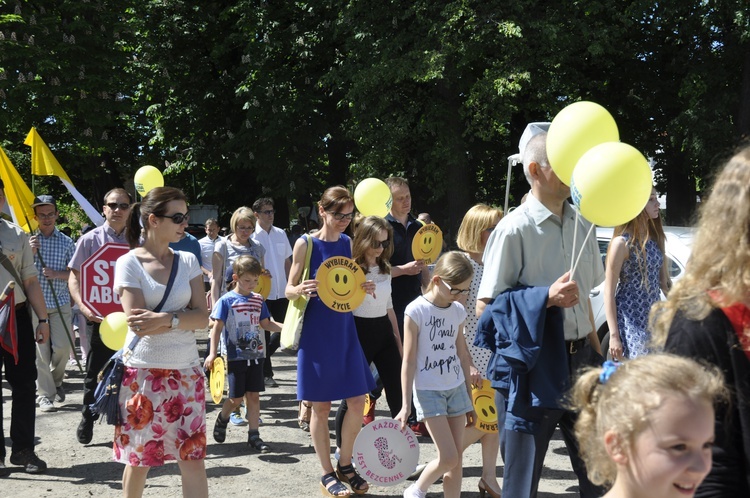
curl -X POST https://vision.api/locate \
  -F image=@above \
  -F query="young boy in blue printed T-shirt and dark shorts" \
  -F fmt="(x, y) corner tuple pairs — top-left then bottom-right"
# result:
(204, 256), (282, 453)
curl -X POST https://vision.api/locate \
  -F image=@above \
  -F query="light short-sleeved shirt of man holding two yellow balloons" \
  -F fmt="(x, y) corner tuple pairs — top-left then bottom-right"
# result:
(477, 194), (604, 341)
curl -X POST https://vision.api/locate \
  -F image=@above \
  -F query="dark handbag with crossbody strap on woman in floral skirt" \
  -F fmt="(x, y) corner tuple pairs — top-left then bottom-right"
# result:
(89, 251), (180, 425)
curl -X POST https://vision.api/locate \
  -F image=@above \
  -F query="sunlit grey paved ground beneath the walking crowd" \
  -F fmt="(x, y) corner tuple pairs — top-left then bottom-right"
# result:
(0, 335), (578, 498)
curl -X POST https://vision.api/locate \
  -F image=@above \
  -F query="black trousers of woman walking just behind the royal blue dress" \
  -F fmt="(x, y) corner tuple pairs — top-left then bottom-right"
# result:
(336, 315), (401, 447)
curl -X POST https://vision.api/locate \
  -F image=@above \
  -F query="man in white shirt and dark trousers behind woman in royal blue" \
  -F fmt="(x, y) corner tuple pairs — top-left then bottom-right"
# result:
(251, 197), (292, 387)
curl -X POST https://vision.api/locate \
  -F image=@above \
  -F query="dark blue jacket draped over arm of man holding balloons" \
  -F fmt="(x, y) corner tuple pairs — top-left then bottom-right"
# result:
(474, 287), (569, 433)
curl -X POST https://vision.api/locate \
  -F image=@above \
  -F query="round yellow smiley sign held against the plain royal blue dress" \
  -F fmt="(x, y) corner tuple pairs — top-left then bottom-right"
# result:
(315, 256), (365, 313)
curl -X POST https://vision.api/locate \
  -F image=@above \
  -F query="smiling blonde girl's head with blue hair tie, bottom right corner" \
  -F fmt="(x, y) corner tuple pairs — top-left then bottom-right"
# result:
(571, 353), (727, 498)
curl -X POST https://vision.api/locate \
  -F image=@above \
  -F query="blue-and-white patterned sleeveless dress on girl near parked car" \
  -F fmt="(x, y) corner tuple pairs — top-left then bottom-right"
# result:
(615, 233), (664, 358)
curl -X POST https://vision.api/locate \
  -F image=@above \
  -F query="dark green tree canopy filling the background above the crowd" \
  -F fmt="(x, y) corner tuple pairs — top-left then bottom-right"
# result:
(0, 0), (750, 233)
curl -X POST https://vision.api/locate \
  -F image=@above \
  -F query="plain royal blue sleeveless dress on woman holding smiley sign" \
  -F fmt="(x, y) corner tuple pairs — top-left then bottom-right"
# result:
(297, 234), (375, 401)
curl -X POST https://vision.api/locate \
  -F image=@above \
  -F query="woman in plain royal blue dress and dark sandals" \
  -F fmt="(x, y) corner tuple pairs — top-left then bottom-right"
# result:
(286, 187), (375, 496)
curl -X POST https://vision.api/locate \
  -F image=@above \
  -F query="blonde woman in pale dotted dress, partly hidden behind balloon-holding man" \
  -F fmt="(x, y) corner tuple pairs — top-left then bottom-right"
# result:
(456, 204), (505, 498)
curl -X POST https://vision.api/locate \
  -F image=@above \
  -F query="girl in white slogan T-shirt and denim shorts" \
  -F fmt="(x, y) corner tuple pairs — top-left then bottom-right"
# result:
(396, 251), (476, 498)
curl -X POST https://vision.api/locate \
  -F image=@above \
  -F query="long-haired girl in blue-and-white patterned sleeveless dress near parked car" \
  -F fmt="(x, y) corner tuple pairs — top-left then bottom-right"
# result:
(604, 190), (671, 360)
